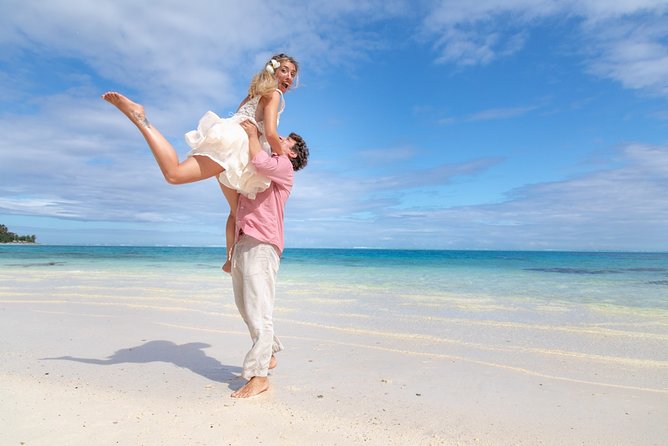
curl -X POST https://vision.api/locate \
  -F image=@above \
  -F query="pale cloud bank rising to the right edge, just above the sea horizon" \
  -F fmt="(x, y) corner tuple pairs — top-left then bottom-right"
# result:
(440, 145), (668, 250)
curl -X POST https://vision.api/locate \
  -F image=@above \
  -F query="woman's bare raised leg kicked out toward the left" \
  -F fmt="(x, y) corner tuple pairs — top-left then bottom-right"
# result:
(102, 92), (223, 184)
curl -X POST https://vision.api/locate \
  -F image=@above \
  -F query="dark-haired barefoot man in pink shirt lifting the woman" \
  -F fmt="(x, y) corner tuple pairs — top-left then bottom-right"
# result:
(232, 121), (309, 398)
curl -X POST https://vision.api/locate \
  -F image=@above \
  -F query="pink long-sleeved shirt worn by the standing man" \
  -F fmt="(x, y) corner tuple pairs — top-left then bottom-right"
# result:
(236, 151), (295, 255)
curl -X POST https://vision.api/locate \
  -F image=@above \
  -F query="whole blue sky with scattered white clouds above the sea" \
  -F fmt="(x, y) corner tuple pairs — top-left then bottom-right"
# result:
(0, 0), (668, 251)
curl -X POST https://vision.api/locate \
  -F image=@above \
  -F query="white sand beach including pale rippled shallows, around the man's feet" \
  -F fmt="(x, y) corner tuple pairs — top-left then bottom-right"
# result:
(0, 266), (668, 446)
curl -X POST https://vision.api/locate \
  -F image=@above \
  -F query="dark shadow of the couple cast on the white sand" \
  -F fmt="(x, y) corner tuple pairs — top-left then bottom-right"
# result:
(41, 341), (241, 384)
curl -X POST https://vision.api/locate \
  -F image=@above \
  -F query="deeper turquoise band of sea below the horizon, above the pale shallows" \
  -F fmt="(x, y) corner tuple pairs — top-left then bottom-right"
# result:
(0, 245), (668, 311)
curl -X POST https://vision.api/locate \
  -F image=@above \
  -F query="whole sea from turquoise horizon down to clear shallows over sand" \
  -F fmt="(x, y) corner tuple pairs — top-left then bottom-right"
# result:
(5, 245), (668, 395)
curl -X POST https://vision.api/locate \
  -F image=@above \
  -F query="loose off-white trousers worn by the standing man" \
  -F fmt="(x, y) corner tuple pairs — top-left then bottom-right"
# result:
(232, 235), (283, 379)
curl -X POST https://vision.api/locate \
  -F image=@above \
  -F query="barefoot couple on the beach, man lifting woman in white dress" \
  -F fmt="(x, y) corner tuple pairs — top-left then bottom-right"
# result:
(102, 54), (309, 398)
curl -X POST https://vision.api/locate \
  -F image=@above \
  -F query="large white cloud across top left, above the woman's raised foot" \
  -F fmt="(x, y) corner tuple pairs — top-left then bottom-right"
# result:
(0, 0), (406, 108)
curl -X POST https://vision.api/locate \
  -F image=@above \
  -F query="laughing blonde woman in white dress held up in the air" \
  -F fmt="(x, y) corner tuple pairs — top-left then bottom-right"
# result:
(102, 54), (299, 273)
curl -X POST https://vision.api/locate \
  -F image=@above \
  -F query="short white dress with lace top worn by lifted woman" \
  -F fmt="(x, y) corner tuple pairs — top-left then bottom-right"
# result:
(185, 90), (285, 199)
